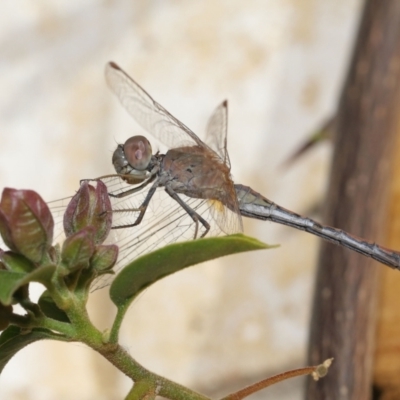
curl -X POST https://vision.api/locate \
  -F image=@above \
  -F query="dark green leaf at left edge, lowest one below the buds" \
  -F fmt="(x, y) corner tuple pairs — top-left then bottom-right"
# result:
(0, 325), (67, 373)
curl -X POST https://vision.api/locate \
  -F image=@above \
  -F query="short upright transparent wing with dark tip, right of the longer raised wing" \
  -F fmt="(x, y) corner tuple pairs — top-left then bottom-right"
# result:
(205, 100), (231, 169)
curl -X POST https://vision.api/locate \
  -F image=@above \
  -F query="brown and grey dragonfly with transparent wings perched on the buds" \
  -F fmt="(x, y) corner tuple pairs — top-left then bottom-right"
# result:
(89, 62), (400, 269)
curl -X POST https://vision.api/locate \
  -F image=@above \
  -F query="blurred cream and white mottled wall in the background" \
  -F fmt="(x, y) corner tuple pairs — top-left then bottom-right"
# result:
(0, 0), (362, 400)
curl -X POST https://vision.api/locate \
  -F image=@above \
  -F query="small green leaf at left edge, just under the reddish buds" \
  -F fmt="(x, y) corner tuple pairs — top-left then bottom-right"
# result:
(0, 265), (56, 305)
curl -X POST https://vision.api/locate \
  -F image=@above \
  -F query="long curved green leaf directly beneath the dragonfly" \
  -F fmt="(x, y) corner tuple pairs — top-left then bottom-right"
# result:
(110, 234), (276, 307)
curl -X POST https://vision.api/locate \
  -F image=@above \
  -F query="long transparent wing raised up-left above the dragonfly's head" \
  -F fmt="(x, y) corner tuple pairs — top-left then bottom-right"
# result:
(105, 62), (205, 148)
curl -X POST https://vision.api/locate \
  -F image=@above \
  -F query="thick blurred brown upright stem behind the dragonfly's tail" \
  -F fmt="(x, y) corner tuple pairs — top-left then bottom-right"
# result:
(306, 0), (400, 400)
